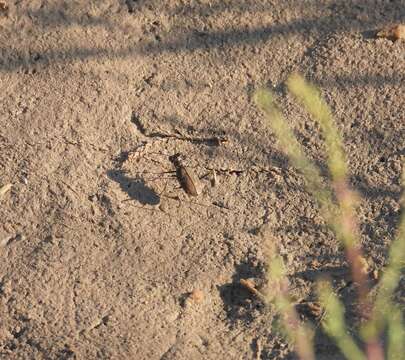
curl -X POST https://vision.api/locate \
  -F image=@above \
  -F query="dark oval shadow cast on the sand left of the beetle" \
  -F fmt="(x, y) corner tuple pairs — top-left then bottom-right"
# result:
(107, 170), (160, 205)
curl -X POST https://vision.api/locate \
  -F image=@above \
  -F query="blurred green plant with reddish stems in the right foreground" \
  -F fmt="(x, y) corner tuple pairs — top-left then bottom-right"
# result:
(254, 74), (405, 360)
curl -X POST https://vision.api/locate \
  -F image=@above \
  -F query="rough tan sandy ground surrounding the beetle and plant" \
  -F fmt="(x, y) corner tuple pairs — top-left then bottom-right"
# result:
(0, 0), (405, 359)
